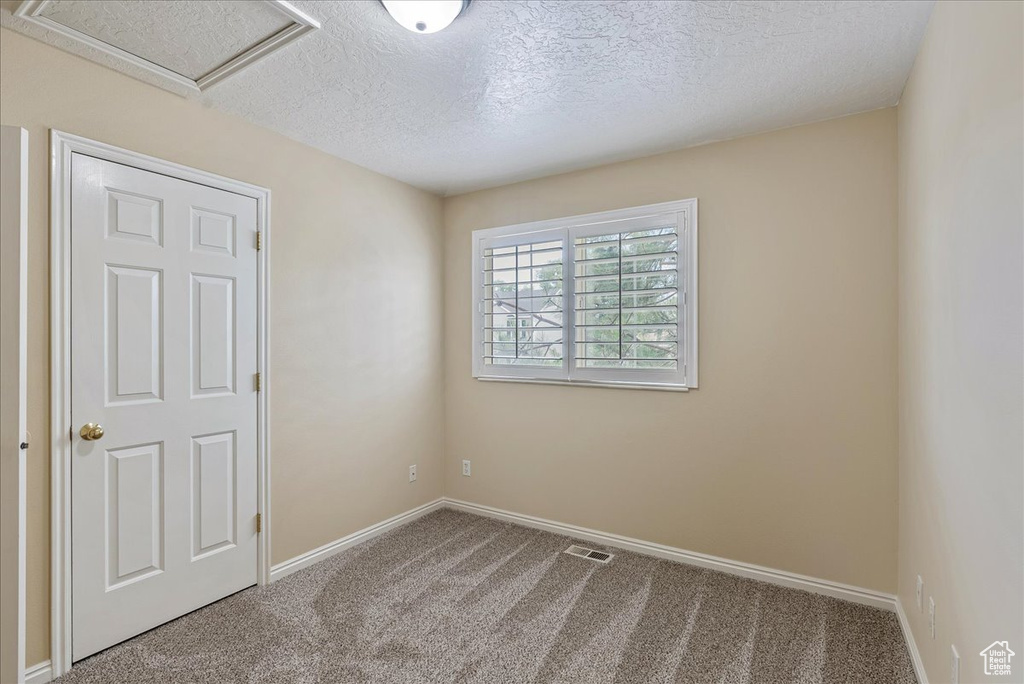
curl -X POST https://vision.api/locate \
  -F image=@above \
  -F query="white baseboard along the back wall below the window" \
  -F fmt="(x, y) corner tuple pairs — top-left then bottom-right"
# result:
(444, 499), (896, 610)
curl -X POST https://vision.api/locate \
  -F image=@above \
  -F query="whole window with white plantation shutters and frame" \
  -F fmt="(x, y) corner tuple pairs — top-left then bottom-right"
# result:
(473, 200), (697, 389)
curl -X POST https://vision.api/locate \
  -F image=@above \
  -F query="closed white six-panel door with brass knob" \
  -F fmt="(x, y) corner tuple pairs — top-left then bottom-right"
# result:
(71, 154), (257, 660)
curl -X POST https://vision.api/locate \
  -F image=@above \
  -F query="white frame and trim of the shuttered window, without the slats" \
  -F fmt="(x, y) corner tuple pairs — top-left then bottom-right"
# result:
(471, 199), (698, 391)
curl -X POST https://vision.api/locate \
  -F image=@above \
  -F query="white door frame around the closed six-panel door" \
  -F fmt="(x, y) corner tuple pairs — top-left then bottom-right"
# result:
(50, 129), (270, 678)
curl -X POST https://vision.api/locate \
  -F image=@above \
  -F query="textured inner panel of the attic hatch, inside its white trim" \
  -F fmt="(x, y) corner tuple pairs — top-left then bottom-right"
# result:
(40, 0), (292, 80)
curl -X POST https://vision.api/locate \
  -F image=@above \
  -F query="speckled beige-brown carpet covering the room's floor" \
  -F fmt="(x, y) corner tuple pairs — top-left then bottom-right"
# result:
(56, 510), (915, 684)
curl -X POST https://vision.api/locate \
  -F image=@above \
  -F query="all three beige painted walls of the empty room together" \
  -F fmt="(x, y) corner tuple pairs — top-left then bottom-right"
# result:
(12, 3), (1024, 681)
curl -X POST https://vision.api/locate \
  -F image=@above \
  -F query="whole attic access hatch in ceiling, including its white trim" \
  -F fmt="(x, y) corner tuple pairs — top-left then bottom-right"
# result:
(13, 0), (319, 93)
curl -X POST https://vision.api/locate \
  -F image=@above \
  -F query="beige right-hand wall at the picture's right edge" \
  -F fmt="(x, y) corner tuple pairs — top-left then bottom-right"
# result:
(899, 2), (1024, 683)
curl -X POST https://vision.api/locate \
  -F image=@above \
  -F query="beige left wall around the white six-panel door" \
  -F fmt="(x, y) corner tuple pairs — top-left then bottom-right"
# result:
(0, 31), (443, 665)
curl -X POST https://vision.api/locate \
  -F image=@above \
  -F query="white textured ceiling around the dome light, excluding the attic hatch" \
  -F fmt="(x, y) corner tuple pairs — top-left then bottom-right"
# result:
(4, 0), (932, 195)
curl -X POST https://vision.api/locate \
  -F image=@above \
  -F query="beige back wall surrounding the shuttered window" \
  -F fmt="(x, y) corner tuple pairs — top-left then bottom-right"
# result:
(444, 109), (897, 592)
